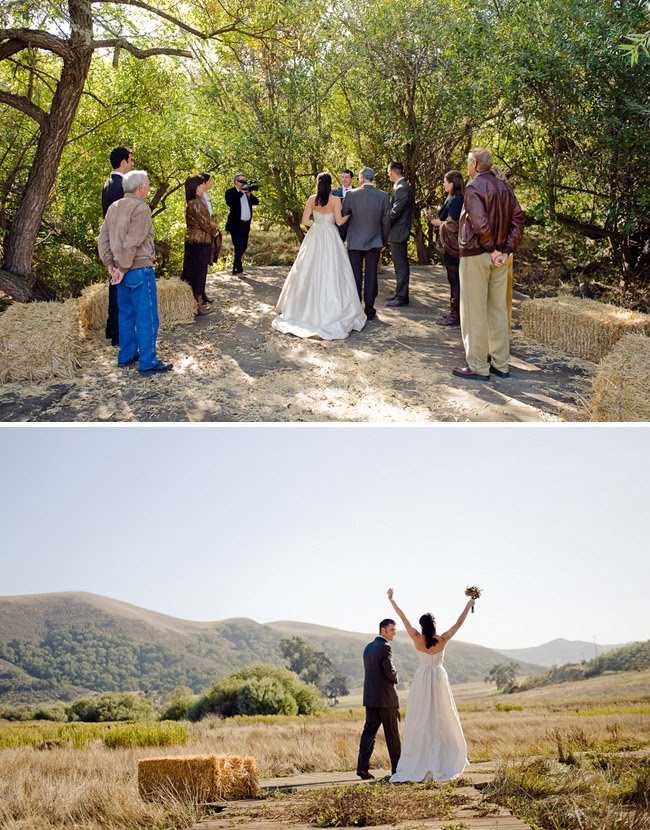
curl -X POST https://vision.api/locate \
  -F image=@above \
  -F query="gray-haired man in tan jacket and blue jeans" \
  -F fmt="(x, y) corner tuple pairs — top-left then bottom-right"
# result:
(98, 170), (172, 375)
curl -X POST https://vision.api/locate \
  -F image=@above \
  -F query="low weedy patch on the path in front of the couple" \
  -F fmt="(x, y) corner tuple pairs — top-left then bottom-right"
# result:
(294, 783), (466, 827)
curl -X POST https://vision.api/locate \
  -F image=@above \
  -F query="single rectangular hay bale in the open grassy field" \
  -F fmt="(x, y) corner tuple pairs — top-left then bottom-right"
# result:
(138, 755), (257, 802)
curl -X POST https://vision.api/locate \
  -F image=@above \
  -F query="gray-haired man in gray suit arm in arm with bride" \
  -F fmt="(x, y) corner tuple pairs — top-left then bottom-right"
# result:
(341, 167), (390, 320)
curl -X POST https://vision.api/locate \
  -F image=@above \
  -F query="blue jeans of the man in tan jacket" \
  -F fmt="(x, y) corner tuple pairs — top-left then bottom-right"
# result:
(117, 266), (158, 369)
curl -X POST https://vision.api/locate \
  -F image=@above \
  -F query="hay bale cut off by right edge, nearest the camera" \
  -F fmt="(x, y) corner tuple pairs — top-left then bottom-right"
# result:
(591, 334), (650, 421)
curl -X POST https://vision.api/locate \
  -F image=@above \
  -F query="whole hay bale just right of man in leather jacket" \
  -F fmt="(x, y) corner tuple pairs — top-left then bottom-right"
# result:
(520, 297), (650, 362)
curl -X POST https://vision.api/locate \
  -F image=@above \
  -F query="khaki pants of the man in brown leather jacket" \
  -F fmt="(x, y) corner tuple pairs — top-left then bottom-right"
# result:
(460, 253), (510, 375)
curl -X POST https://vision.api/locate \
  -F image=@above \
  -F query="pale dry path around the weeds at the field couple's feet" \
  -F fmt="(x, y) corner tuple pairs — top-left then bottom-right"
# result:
(191, 763), (531, 830)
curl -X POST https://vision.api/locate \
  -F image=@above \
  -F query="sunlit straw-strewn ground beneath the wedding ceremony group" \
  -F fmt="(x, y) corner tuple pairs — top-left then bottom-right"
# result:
(0, 266), (595, 423)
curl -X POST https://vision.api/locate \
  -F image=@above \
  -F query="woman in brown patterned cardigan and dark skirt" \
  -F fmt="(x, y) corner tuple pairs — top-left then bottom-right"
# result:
(181, 176), (219, 315)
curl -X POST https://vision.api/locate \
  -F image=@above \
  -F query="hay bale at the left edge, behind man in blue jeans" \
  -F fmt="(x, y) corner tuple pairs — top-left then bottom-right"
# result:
(0, 300), (81, 383)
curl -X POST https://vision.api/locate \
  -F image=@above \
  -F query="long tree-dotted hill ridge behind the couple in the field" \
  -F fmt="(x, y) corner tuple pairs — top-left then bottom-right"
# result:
(0, 593), (543, 704)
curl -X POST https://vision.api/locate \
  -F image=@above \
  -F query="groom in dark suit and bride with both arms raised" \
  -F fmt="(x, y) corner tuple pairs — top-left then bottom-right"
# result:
(357, 588), (475, 783)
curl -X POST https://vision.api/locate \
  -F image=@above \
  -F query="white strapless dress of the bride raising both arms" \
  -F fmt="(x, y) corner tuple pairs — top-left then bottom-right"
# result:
(390, 650), (469, 782)
